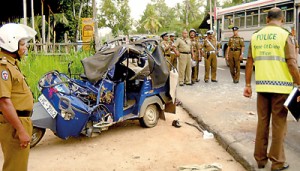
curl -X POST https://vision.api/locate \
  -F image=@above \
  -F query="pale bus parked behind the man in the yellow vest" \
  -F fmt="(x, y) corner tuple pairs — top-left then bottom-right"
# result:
(216, 0), (300, 66)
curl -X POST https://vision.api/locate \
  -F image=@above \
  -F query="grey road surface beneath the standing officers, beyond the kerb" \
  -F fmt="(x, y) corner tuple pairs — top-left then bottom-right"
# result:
(177, 58), (300, 171)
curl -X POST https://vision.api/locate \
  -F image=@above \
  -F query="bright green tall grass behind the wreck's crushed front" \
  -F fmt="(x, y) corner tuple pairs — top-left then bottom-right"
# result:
(20, 52), (91, 101)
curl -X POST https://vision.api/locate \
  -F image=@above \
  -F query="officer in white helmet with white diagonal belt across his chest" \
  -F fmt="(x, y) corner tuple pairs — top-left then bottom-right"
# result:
(203, 30), (220, 83)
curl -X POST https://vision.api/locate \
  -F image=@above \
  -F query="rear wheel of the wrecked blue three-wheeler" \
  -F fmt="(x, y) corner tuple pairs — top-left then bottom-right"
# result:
(139, 104), (159, 128)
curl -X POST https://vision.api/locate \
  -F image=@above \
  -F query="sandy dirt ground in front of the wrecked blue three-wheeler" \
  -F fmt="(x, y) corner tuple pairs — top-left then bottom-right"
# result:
(0, 107), (245, 171)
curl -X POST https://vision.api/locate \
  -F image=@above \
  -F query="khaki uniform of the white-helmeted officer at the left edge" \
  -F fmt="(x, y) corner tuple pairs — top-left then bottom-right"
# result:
(0, 52), (33, 171)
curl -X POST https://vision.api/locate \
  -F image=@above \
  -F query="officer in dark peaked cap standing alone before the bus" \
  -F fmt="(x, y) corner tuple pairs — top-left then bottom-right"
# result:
(226, 27), (245, 83)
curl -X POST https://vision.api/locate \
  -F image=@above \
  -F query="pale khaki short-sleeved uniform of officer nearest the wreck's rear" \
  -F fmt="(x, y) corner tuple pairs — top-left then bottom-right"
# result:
(174, 38), (192, 85)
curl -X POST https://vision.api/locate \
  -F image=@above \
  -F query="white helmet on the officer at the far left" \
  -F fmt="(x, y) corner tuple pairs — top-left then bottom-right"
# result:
(0, 23), (36, 52)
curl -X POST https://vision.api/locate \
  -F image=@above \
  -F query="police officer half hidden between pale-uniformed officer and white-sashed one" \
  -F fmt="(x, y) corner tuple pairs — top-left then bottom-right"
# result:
(189, 29), (202, 84)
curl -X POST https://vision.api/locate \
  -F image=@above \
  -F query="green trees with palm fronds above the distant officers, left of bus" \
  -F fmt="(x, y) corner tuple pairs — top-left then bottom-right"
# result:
(137, 0), (204, 34)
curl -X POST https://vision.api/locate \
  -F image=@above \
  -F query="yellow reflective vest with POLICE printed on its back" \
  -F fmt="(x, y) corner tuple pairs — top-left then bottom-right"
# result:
(251, 26), (293, 94)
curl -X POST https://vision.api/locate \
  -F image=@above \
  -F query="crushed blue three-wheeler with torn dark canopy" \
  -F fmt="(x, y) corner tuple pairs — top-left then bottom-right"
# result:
(31, 39), (177, 147)
